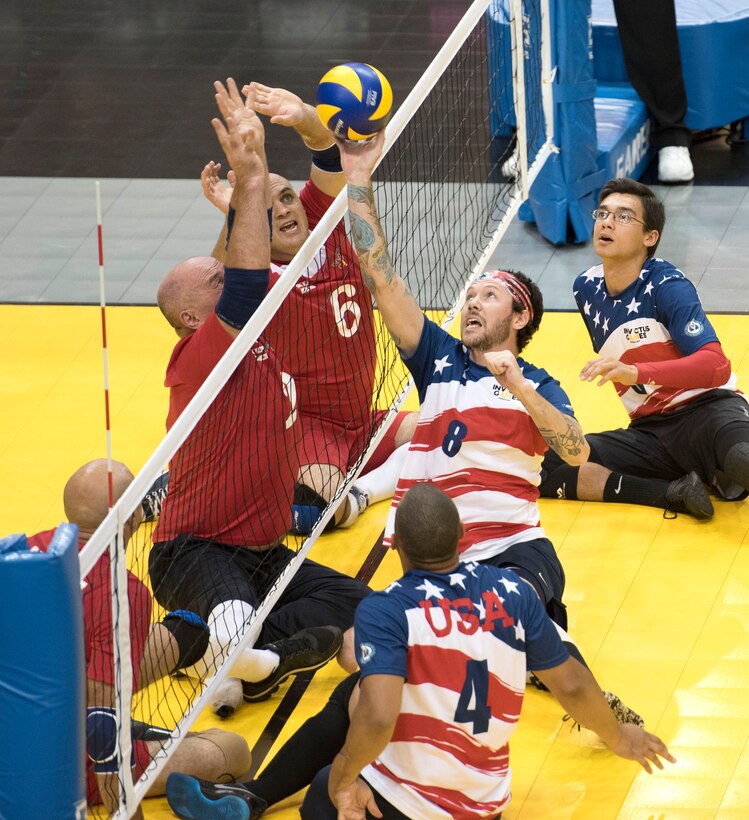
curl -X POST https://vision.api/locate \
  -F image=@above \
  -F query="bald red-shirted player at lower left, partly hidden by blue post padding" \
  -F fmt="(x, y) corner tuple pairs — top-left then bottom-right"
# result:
(29, 459), (250, 812)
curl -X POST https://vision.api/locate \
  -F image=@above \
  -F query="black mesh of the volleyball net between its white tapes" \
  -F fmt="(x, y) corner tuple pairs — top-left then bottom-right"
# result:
(92, 3), (545, 812)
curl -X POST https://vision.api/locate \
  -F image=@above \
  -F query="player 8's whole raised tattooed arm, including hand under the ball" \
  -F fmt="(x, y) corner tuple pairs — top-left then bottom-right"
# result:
(338, 133), (424, 357)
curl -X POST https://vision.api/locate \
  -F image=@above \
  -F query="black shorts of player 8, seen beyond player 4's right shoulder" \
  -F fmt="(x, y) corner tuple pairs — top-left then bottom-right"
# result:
(480, 538), (567, 630)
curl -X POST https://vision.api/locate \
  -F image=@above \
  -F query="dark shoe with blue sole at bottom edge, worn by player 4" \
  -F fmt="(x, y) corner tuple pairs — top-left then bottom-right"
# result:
(166, 772), (268, 820)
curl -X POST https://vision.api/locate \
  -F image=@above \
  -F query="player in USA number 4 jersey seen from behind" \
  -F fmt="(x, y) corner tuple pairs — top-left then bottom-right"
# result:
(167, 483), (674, 820)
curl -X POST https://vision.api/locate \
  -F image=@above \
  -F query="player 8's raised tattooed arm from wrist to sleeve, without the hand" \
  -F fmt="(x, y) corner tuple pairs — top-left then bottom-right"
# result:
(348, 182), (424, 355)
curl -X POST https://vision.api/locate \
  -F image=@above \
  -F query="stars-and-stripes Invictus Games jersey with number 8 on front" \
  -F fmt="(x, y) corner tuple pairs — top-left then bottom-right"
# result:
(385, 319), (573, 560)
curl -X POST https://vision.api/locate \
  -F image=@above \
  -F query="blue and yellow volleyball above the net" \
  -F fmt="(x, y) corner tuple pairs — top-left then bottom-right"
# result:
(316, 63), (393, 141)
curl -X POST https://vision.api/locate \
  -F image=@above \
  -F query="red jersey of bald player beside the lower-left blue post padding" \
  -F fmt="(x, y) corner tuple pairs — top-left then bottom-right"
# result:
(28, 530), (151, 689)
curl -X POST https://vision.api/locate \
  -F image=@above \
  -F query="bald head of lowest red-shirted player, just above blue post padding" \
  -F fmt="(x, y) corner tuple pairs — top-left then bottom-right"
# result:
(62, 458), (133, 541)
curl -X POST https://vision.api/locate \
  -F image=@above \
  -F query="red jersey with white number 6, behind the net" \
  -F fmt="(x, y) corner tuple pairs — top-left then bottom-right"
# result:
(267, 181), (377, 427)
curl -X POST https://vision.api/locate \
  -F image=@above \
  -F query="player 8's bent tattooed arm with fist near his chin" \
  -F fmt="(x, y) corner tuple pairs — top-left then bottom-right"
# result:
(481, 350), (590, 467)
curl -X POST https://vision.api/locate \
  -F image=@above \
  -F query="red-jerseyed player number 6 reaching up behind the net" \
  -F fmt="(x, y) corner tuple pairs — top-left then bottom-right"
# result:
(201, 83), (416, 533)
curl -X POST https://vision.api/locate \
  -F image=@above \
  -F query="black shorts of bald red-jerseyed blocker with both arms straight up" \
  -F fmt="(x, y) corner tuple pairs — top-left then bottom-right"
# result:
(148, 536), (370, 644)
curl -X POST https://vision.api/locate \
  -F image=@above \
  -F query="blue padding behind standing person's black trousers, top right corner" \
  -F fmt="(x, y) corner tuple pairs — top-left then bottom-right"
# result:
(593, 0), (749, 131)
